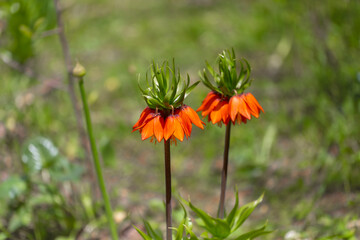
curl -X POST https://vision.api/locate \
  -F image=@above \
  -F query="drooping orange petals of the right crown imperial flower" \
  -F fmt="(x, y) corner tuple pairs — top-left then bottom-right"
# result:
(196, 91), (264, 125)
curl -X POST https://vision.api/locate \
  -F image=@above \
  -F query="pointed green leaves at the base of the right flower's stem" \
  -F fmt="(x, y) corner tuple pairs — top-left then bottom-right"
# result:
(186, 191), (272, 240)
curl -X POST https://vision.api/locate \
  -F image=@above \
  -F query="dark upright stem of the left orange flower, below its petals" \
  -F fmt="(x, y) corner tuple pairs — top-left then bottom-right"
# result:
(164, 139), (172, 240)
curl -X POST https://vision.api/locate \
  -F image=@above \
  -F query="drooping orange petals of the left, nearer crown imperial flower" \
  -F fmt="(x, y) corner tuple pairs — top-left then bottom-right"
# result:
(133, 105), (205, 143)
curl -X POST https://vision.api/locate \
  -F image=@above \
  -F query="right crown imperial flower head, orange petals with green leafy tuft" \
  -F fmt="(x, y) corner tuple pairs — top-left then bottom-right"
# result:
(197, 50), (264, 125)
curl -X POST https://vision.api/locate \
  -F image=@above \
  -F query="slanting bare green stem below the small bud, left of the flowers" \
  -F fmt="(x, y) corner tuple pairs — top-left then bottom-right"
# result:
(79, 78), (118, 240)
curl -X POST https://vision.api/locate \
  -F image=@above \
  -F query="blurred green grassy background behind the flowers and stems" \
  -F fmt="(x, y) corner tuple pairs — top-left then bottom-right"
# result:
(0, 0), (360, 239)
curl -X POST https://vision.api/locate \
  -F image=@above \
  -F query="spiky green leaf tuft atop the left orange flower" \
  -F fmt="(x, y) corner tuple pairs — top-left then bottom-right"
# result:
(139, 60), (199, 110)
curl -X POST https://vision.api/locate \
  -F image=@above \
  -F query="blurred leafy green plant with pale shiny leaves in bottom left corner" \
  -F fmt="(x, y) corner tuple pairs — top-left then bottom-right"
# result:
(0, 137), (83, 239)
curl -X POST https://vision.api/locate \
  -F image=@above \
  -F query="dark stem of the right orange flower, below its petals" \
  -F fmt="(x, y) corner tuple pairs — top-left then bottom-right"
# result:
(218, 122), (231, 218)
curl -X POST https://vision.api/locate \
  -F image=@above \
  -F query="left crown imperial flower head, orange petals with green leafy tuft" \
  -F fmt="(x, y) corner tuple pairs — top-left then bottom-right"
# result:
(133, 62), (205, 143)
